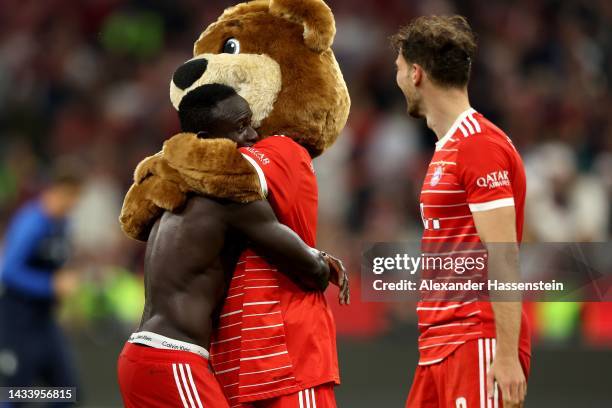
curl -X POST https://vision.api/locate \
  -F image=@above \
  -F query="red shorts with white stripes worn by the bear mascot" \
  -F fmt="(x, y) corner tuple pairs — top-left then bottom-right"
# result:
(237, 383), (336, 408)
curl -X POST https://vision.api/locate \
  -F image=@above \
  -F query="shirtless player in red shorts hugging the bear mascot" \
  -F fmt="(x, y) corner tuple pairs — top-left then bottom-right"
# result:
(118, 84), (342, 408)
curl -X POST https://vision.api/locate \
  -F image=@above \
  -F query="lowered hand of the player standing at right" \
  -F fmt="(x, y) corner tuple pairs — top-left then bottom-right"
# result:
(487, 354), (527, 408)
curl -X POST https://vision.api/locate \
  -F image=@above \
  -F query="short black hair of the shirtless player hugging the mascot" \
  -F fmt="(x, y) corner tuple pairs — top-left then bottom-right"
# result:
(179, 84), (237, 133)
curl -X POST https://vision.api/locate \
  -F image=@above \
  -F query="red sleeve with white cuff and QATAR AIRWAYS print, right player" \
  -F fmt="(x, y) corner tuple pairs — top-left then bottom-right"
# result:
(457, 135), (514, 212)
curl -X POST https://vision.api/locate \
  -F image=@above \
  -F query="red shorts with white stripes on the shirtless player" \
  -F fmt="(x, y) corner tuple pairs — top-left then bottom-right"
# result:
(118, 343), (229, 408)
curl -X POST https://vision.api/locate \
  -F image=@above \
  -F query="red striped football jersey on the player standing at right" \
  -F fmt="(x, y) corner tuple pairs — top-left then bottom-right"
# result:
(417, 109), (530, 365)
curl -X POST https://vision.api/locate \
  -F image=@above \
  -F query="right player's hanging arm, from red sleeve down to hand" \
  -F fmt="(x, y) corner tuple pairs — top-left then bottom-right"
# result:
(457, 135), (527, 408)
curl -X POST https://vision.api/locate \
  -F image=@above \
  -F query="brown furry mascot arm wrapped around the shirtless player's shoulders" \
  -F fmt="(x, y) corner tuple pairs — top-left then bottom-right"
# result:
(119, 133), (263, 241)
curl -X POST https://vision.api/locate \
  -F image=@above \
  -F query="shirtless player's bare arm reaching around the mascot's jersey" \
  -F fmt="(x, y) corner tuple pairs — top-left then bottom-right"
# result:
(227, 200), (330, 290)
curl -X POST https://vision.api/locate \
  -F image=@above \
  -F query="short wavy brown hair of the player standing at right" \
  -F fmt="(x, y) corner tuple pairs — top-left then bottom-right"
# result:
(391, 15), (477, 88)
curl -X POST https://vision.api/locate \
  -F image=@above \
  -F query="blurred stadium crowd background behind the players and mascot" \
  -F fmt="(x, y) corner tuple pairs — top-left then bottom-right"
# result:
(0, 0), (612, 408)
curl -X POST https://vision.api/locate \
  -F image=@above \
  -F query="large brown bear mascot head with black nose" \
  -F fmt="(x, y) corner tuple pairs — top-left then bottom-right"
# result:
(170, 0), (350, 157)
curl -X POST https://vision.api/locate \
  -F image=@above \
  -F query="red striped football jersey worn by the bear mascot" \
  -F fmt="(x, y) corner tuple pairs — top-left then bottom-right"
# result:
(210, 136), (340, 406)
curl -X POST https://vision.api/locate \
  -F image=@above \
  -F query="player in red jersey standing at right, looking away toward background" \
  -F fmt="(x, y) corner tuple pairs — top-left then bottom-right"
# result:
(392, 16), (530, 408)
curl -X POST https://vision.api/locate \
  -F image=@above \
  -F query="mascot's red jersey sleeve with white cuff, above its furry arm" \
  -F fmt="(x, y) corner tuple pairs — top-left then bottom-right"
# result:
(240, 136), (303, 214)
